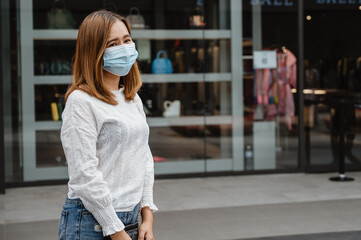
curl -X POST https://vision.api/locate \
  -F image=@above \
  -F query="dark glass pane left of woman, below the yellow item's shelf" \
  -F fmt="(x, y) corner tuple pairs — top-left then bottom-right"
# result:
(36, 131), (66, 167)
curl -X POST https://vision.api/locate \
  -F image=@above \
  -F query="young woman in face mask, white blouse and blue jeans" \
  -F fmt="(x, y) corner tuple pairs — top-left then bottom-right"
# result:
(59, 10), (157, 240)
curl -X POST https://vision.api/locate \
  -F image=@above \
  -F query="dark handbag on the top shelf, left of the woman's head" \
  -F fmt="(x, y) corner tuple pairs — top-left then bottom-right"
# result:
(47, 0), (74, 29)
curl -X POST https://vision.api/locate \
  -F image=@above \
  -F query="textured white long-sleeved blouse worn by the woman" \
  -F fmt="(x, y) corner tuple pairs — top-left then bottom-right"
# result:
(61, 88), (158, 236)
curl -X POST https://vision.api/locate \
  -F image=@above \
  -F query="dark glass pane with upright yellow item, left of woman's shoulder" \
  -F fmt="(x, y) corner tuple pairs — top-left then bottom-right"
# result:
(35, 85), (68, 121)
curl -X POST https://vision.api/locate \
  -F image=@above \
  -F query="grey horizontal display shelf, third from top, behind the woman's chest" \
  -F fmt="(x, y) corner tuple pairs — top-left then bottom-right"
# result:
(35, 116), (232, 131)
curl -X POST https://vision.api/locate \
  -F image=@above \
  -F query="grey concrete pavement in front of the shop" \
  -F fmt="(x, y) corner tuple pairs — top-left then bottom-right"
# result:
(0, 172), (361, 240)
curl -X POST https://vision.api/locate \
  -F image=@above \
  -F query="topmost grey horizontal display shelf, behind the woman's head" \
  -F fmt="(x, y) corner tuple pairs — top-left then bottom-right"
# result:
(33, 29), (231, 40)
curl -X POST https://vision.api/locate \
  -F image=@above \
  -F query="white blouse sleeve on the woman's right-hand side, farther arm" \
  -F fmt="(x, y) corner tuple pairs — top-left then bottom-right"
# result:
(135, 94), (158, 211)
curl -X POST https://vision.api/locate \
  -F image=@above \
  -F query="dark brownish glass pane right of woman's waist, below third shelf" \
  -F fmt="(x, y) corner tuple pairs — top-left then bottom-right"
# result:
(149, 125), (206, 162)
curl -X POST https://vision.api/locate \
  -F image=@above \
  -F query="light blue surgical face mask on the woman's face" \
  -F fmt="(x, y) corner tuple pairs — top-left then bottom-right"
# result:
(103, 43), (138, 76)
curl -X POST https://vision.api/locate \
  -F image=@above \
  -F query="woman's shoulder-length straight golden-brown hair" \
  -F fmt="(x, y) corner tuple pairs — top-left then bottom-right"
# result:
(65, 10), (142, 105)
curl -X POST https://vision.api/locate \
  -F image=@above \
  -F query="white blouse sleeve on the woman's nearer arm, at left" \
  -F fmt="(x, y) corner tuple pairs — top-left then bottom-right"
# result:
(61, 92), (124, 236)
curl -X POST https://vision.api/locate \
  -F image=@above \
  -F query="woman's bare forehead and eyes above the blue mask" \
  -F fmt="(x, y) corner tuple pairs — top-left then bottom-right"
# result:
(107, 20), (133, 48)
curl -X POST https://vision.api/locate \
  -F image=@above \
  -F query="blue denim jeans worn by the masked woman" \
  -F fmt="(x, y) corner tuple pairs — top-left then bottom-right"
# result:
(58, 197), (139, 240)
